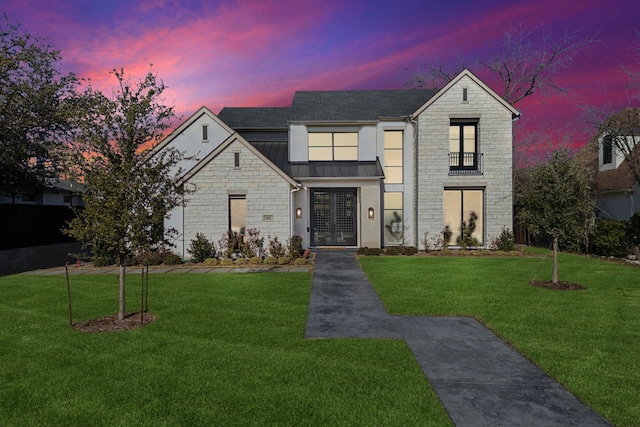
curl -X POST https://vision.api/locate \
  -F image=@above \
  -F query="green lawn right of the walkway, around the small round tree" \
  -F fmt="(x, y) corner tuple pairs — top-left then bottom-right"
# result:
(360, 252), (640, 426)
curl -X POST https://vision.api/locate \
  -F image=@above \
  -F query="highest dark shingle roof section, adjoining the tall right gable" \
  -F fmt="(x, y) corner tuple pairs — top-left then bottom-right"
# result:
(290, 89), (437, 121)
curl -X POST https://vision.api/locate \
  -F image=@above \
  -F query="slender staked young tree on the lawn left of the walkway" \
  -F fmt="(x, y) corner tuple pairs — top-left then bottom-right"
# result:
(66, 70), (182, 320)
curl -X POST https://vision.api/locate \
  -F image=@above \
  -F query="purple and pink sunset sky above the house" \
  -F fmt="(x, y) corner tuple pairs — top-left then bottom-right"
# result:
(0, 0), (640, 154)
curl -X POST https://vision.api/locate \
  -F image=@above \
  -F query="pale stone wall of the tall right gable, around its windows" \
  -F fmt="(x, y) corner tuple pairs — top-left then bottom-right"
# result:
(416, 76), (513, 245)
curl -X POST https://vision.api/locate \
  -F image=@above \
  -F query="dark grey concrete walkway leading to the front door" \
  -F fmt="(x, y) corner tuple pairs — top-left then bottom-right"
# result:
(305, 251), (610, 427)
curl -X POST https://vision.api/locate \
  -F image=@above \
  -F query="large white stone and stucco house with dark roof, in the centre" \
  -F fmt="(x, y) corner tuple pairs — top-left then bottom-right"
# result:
(156, 70), (520, 257)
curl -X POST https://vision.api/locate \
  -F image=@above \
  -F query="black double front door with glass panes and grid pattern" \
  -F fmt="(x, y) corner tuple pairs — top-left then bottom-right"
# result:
(311, 188), (357, 246)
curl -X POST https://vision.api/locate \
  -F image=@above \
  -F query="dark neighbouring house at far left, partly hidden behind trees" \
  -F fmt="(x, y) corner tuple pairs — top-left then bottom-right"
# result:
(0, 180), (84, 206)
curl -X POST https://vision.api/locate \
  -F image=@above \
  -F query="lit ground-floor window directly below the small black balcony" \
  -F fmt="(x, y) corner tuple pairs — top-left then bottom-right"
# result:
(444, 190), (484, 246)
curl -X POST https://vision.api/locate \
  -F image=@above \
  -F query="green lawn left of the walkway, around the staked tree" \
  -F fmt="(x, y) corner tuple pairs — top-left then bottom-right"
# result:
(0, 273), (450, 426)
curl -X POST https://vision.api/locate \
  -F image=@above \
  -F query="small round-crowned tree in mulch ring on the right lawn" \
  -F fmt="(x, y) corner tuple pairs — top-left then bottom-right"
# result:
(516, 150), (595, 283)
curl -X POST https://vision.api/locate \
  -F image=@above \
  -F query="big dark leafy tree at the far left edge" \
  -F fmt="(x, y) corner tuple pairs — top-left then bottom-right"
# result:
(0, 15), (79, 198)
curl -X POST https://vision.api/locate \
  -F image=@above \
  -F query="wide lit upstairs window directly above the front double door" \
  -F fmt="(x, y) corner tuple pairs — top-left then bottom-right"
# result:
(309, 132), (358, 161)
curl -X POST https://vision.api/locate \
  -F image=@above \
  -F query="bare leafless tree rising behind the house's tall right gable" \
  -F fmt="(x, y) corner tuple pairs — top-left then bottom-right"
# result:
(405, 26), (596, 105)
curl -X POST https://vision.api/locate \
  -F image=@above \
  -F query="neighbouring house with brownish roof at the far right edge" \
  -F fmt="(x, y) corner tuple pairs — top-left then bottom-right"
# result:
(583, 108), (640, 221)
